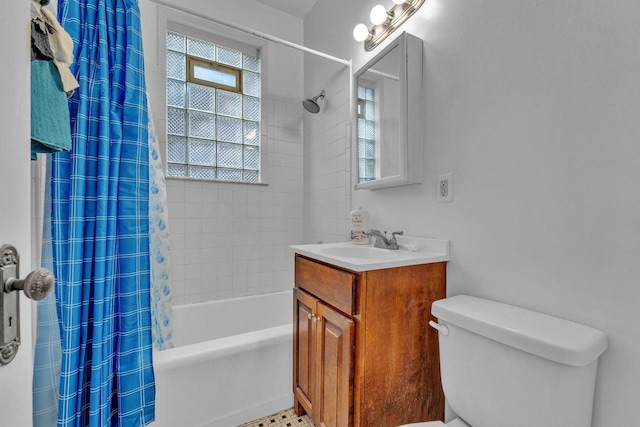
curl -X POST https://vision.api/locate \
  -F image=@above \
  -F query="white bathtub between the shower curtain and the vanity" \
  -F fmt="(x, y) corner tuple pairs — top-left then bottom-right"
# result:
(152, 291), (293, 427)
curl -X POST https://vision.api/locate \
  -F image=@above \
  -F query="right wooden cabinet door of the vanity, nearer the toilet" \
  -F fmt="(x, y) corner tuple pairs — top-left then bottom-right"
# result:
(314, 302), (354, 427)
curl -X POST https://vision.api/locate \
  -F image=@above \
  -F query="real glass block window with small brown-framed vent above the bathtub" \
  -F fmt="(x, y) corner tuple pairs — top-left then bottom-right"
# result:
(167, 31), (261, 183)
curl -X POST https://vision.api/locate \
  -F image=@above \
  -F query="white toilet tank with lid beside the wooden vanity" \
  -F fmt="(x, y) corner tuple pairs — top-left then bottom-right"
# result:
(431, 295), (607, 427)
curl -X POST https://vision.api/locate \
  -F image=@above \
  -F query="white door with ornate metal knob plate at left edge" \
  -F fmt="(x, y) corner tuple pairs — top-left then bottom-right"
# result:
(0, 1), (32, 426)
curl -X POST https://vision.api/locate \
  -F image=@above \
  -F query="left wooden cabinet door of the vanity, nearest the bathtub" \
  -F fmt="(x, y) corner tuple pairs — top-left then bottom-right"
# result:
(293, 288), (318, 417)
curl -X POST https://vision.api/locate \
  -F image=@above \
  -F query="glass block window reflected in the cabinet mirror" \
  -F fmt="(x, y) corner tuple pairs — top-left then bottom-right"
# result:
(358, 85), (376, 182)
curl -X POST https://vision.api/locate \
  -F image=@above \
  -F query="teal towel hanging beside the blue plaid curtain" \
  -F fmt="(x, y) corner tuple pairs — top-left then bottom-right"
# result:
(31, 60), (71, 159)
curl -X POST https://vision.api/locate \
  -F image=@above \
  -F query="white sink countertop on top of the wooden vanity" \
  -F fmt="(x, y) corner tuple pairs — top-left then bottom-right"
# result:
(291, 236), (449, 271)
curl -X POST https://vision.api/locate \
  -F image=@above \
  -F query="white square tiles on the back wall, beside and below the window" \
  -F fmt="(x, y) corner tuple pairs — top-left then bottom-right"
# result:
(161, 95), (303, 305)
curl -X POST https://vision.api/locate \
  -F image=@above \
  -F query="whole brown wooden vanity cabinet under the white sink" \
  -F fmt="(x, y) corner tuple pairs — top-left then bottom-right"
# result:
(293, 254), (446, 427)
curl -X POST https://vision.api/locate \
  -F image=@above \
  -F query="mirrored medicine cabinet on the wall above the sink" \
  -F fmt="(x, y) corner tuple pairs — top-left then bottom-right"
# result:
(353, 33), (423, 190)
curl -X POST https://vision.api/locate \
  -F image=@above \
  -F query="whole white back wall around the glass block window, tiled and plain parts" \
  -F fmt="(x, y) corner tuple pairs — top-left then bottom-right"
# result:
(140, 0), (303, 304)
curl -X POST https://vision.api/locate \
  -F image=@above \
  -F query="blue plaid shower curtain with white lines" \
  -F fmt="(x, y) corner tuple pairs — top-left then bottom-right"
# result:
(51, 0), (155, 427)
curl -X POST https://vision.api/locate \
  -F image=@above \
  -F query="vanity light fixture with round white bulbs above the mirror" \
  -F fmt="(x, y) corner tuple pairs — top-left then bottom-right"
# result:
(353, 0), (425, 52)
